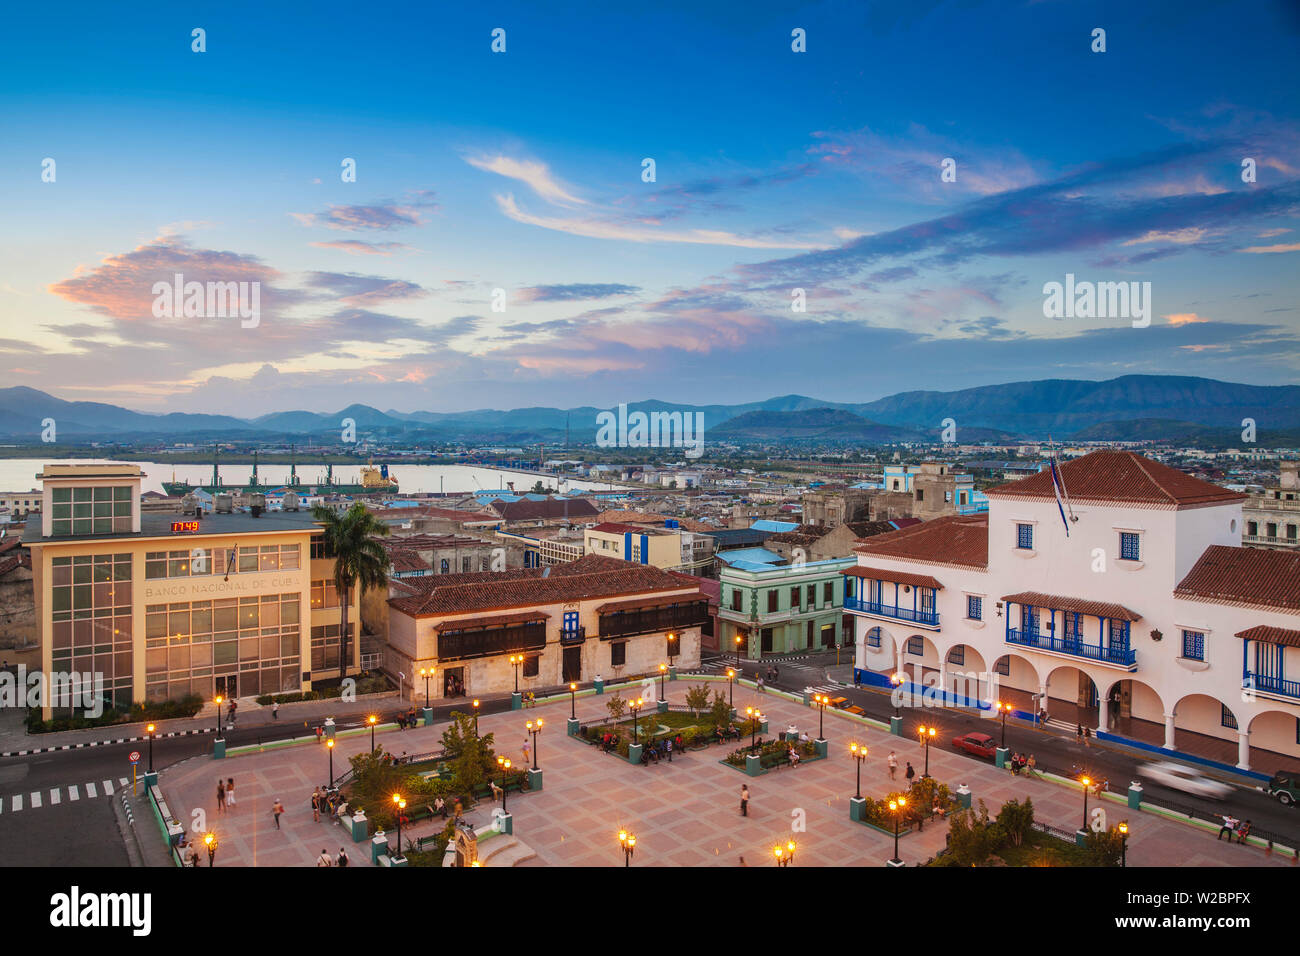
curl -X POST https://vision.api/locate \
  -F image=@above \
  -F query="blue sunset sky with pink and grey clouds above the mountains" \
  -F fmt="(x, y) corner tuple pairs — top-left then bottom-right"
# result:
(0, 0), (1300, 416)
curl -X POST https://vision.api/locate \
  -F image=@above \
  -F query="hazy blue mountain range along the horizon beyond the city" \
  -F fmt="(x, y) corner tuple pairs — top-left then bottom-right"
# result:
(0, 375), (1300, 445)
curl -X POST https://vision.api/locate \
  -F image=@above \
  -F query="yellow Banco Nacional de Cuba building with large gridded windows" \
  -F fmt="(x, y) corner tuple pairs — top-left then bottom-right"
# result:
(23, 464), (360, 719)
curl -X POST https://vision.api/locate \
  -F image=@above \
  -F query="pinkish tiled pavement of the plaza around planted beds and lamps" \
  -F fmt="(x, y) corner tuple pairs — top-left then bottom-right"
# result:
(161, 678), (1292, 866)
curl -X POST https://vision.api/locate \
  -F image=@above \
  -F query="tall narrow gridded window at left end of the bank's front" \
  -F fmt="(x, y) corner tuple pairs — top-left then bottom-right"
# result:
(51, 554), (134, 714)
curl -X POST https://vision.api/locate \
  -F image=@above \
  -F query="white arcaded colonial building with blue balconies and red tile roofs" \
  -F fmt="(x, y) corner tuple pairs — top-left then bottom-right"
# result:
(845, 451), (1300, 773)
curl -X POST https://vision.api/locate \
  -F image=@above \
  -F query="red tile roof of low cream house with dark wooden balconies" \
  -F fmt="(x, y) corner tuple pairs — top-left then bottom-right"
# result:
(389, 554), (698, 617)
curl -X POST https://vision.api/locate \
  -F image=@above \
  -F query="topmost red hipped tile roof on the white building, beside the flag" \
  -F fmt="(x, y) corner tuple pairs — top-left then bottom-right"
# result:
(985, 451), (1245, 507)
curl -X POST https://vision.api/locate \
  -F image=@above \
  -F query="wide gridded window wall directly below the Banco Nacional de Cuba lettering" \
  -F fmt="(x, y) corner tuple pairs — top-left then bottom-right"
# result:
(144, 593), (302, 701)
